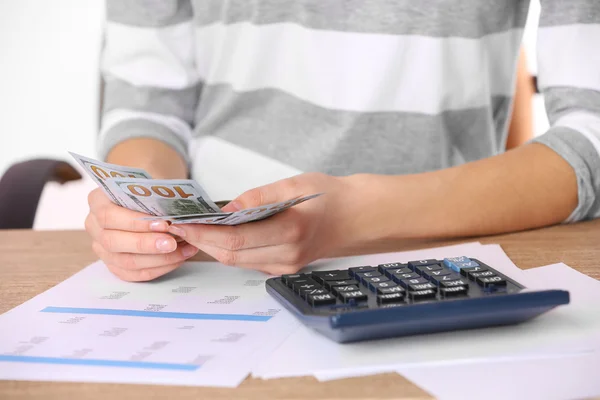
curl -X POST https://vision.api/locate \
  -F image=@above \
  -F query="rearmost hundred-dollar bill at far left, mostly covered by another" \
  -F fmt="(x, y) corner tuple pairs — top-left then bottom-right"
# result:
(69, 152), (152, 206)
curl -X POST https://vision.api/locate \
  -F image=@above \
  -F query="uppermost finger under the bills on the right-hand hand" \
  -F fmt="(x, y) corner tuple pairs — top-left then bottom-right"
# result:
(169, 209), (308, 250)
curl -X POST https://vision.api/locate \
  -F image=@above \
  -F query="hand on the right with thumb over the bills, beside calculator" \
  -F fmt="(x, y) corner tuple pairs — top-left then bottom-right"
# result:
(169, 173), (361, 275)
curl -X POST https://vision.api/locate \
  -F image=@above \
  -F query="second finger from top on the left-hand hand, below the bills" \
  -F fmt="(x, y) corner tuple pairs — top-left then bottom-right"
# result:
(86, 216), (177, 254)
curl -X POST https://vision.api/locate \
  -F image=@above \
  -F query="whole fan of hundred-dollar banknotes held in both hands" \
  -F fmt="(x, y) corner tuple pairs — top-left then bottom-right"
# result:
(70, 153), (322, 225)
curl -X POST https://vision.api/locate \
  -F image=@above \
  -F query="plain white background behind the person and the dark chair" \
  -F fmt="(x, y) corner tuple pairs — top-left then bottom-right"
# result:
(0, 0), (547, 229)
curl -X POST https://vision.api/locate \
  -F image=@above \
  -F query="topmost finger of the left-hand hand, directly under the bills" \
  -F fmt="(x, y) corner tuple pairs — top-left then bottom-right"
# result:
(88, 189), (169, 232)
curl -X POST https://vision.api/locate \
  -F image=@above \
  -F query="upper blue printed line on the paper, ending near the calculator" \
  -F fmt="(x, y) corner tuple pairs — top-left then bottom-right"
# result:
(41, 307), (272, 322)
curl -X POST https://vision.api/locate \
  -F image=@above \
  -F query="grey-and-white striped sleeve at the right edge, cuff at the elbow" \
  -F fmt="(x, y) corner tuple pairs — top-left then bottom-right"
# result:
(534, 0), (600, 222)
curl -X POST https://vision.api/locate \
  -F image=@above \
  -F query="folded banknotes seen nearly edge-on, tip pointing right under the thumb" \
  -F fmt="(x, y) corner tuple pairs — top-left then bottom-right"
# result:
(142, 193), (323, 225)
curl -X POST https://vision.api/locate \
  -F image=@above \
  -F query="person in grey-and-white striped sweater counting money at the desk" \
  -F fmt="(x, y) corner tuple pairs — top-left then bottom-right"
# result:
(86, 0), (600, 281)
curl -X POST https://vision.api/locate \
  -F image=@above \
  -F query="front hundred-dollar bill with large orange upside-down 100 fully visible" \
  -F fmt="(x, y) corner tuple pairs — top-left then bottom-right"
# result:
(105, 178), (228, 216)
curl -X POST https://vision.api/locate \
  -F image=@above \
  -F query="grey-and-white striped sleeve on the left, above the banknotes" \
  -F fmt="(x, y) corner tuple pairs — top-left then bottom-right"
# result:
(98, 0), (200, 162)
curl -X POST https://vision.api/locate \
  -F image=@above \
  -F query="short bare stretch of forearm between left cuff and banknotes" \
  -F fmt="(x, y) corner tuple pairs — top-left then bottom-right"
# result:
(107, 138), (188, 179)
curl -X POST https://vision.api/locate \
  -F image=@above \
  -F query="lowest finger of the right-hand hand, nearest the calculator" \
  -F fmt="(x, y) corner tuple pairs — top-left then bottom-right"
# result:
(197, 244), (309, 269)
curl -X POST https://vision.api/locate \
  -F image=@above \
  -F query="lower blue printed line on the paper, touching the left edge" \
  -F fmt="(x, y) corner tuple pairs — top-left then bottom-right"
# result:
(0, 354), (200, 371)
